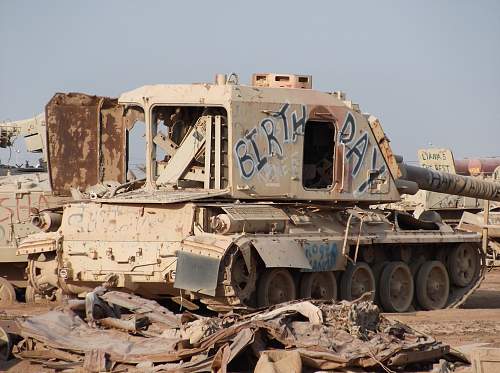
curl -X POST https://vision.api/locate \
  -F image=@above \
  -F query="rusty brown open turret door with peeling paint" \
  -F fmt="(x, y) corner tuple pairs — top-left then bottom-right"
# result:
(46, 93), (126, 195)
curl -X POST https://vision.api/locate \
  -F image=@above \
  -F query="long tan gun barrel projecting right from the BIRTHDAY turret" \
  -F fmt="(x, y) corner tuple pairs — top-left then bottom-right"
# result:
(400, 163), (500, 202)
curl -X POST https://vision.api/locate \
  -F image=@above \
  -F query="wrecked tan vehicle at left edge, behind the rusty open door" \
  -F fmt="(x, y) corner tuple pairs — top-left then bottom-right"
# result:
(0, 114), (54, 305)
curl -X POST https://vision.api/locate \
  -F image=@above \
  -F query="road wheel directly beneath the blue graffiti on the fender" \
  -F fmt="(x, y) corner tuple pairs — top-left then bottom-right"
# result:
(300, 272), (337, 300)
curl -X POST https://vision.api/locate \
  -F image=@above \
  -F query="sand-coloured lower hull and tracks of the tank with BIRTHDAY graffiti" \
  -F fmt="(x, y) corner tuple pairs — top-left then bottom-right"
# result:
(19, 202), (485, 312)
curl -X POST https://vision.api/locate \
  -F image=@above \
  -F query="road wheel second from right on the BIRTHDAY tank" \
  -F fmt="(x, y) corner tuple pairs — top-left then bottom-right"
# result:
(417, 260), (450, 310)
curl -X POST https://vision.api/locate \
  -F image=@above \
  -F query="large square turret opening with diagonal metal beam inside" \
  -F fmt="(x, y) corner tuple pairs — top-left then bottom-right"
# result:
(152, 106), (228, 189)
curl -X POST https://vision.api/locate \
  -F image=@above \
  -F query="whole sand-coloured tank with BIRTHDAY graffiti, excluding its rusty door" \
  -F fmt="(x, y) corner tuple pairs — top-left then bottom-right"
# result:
(17, 74), (500, 312)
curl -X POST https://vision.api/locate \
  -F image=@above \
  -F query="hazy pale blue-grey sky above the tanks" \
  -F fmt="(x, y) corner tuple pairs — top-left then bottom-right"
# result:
(0, 0), (500, 165)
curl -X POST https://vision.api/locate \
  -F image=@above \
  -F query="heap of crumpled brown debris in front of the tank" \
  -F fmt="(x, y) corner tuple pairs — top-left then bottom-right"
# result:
(0, 288), (449, 373)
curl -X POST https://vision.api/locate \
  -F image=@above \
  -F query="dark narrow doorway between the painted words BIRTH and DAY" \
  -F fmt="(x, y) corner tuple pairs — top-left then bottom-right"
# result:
(302, 120), (335, 189)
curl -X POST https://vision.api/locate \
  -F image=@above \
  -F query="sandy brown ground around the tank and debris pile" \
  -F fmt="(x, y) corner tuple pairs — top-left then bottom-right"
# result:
(0, 267), (500, 372)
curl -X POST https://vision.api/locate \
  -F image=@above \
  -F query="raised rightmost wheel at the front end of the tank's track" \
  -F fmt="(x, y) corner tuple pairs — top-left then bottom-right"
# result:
(447, 243), (481, 287)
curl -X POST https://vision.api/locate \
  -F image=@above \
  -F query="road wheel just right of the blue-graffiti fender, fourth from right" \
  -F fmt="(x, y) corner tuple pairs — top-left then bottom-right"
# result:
(340, 262), (375, 300)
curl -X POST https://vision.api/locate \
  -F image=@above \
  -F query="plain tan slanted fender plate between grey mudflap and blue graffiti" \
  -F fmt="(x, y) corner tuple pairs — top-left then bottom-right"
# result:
(252, 237), (311, 269)
